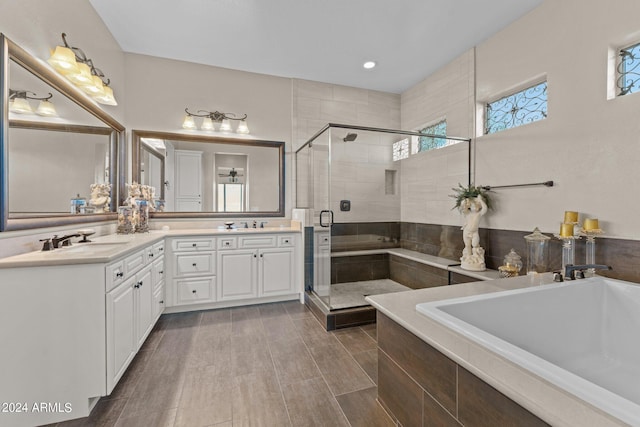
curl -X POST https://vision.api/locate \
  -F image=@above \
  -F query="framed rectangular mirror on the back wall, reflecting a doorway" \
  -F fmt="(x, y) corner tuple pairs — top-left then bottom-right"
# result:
(132, 130), (284, 218)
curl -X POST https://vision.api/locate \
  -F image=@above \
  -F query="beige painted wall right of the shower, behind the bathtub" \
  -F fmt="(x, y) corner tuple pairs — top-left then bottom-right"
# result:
(476, 0), (640, 239)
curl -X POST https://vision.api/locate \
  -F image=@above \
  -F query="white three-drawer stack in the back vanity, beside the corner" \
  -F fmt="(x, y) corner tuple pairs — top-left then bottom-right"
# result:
(167, 236), (216, 307)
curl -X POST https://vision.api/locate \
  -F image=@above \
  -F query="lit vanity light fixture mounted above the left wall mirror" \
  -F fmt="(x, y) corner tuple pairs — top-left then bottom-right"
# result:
(47, 33), (118, 105)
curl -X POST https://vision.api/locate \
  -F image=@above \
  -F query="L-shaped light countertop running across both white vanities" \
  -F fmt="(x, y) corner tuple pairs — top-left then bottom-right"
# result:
(0, 227), (300, 268)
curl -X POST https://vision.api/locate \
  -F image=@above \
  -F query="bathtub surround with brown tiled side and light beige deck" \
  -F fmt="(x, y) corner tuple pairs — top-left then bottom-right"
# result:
(367, 274), (625, 427)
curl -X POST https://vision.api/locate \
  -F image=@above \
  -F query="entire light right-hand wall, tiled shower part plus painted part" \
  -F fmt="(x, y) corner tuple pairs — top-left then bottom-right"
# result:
(402, 0), (640, 239)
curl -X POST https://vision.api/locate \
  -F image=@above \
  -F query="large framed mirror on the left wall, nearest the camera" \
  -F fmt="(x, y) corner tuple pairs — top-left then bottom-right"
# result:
(0, 35), (124, 231)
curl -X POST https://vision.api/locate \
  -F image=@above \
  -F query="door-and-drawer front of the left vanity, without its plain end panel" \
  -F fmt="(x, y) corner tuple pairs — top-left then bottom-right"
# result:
(105, 241), (164, 394)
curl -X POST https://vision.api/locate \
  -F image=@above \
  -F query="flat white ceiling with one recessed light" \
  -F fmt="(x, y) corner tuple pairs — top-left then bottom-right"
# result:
(90, 0), (543, 93)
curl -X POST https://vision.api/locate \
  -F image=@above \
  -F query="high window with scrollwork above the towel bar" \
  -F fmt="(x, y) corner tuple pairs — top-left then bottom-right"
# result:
(484, 81), (547, 134)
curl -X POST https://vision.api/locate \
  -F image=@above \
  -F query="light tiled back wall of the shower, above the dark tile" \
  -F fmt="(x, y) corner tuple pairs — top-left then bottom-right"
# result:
(293, 79), (400, 222)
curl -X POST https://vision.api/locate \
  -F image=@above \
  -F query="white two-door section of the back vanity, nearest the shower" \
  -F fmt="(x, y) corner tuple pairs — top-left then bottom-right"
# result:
(218, 234), (296, 301)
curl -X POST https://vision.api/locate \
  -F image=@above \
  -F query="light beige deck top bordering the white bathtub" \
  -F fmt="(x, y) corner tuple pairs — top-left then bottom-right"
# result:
(366, 273), (622, 427)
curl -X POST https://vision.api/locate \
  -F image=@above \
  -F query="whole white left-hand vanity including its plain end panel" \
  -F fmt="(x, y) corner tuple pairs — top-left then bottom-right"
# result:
(0, 235), (165, 427)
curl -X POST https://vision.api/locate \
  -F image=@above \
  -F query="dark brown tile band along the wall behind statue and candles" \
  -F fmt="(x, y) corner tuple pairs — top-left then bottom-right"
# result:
(331, 222), (640, 286)
